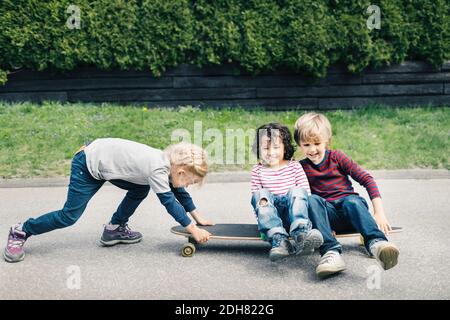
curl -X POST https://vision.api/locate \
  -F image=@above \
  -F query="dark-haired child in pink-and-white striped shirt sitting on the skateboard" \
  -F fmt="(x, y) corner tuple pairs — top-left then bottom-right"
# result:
(251, 123), (323, 261)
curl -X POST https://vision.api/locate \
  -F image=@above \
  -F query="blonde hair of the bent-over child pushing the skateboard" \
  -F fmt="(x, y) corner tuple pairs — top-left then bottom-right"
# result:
(164, 142), (208, 181)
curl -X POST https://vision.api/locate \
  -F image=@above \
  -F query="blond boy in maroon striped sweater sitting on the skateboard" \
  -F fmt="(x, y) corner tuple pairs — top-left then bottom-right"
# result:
(294, 112), (399, 277)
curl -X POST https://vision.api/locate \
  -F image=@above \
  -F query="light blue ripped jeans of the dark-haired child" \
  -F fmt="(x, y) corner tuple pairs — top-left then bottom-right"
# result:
(251, 187), (311, 240)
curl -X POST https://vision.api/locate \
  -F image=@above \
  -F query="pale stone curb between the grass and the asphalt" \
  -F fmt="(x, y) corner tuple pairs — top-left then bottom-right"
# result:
(0, 169), (450, 189)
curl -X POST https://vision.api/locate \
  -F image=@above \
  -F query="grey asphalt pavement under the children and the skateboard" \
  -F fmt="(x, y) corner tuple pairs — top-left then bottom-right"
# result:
(0, 179), (450, 299)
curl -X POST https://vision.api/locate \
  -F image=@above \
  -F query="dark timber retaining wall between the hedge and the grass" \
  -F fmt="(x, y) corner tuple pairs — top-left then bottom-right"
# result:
(0, 61), (450, 110)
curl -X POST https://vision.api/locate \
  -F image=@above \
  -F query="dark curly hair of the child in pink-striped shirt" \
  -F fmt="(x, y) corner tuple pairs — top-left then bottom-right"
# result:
(252, 122), (295, 160)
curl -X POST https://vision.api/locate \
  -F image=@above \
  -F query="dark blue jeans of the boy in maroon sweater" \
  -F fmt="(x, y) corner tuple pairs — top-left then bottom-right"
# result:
(308, 195), (387, 255)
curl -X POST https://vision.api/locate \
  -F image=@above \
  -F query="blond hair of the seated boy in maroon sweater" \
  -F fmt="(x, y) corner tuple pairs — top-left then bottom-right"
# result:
(294, 112), (332, 145)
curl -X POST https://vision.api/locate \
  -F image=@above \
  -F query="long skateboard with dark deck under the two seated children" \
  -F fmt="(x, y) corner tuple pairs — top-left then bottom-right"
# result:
(170, 223), (403, 257)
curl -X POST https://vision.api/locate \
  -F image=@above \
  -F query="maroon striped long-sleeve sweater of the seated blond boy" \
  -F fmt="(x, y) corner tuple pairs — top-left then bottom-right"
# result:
(300, 150), (381, 201)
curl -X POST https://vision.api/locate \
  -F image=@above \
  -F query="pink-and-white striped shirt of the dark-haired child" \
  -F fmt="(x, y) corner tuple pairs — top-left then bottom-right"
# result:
(252, 161), (311, 195)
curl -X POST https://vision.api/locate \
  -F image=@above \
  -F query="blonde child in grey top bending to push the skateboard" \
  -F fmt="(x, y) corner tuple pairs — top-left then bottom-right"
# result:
(3, 138), (212, 262)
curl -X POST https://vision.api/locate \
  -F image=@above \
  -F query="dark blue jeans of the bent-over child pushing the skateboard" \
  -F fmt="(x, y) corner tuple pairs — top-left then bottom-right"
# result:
(23, 151), (150, 236)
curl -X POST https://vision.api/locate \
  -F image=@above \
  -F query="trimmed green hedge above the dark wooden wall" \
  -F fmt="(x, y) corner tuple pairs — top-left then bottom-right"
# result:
(0, 0), (450, 83)
